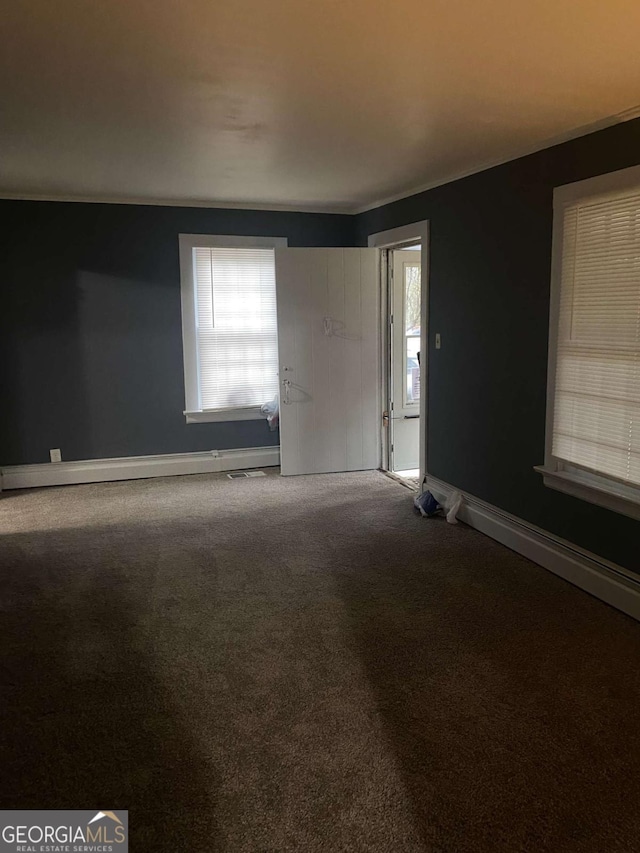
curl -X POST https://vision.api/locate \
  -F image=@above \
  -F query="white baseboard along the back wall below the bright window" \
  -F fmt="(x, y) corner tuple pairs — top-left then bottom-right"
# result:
(0, 447), (280, 490)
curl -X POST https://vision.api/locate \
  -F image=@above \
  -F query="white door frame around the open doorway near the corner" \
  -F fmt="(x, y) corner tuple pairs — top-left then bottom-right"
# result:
(367, 219), (429, 489)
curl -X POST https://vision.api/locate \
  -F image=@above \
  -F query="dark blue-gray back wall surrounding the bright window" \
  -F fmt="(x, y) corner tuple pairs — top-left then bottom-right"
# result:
(0, 201), (354, 465)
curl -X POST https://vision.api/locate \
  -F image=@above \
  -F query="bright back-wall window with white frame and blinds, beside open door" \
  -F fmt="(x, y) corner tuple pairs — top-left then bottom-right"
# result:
(180, 234), (287, 423)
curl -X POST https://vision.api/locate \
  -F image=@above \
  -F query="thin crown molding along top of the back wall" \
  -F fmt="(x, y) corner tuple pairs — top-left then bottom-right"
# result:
(0, 189), (354, 216)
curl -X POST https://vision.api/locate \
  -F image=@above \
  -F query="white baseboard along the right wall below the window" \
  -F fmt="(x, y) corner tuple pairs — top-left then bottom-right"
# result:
(426, 476), (640, 620)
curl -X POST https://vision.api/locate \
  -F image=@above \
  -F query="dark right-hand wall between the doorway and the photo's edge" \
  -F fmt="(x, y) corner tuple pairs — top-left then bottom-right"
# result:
(356, 120), (640, 571)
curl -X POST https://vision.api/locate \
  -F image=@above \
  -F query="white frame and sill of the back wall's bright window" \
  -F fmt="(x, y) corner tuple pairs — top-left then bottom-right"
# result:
(178, 234), (288, 424)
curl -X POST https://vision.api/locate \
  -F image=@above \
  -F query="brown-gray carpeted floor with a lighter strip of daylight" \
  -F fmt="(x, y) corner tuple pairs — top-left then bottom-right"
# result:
(0, 473), (640, 853)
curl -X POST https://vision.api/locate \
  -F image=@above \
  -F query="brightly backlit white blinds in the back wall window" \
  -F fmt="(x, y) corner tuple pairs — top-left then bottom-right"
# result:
(193, 248), (278, 410)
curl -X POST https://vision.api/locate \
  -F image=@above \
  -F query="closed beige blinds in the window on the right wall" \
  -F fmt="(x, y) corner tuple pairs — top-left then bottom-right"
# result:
(552, 190), (640, 485)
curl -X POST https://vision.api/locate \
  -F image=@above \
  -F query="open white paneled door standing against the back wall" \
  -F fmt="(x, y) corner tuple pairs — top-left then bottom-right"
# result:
(275, 249), (381, 475)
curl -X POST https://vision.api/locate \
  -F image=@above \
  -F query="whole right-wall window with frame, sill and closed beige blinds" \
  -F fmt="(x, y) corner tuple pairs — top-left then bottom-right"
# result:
(538, 163), (640, 518)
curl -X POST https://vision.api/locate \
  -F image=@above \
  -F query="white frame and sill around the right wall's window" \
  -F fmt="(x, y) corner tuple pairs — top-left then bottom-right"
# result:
(534, 166), (640, 519)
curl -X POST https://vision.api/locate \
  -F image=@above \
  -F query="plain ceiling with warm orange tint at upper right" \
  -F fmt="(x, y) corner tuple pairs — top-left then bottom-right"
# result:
(0, 0), (640, 211)
